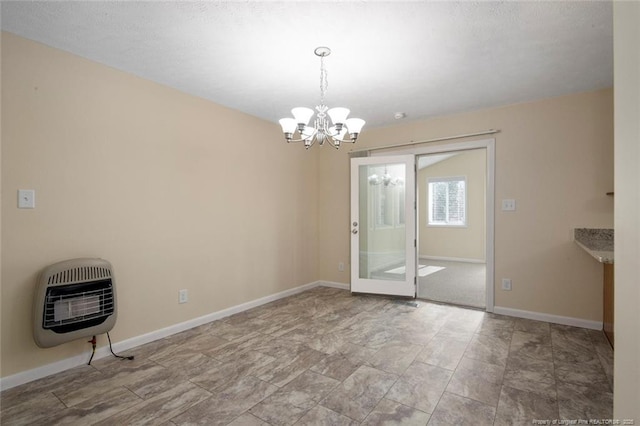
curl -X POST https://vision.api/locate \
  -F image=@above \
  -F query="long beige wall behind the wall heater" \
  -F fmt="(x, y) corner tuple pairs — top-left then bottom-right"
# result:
(1, 33), (318, 377)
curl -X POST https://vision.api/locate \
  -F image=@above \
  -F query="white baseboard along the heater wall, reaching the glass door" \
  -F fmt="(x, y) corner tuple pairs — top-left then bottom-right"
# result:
(0, 281), (349, 391)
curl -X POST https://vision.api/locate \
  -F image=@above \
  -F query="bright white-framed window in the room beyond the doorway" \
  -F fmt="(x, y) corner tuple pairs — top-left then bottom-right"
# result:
(427, 176), (467, 226)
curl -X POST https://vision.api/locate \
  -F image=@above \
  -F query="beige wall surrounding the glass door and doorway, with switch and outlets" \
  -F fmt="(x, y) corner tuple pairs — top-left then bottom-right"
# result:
(319, 89), (613, 321)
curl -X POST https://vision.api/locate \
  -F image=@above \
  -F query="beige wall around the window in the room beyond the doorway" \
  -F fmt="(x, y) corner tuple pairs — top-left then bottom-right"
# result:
(417, 149), (487, 262)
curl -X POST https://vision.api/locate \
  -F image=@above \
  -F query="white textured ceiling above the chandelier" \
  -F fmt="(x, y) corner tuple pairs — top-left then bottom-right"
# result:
(1, 0), (613, 131)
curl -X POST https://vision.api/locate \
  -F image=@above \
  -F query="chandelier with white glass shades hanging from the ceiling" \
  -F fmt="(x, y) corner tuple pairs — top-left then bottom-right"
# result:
(280, 47), (365, 149)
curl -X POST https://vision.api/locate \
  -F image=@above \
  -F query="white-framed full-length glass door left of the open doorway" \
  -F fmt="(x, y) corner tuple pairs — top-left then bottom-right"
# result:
(351, 155), (416, 297)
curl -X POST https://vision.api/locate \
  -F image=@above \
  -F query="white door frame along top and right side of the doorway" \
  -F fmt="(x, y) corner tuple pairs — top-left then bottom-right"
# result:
(371, 138), (496, 312)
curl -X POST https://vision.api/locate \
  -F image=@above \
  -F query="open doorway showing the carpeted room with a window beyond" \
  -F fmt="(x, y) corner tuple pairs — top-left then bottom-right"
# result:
(416, 148), (488, 309)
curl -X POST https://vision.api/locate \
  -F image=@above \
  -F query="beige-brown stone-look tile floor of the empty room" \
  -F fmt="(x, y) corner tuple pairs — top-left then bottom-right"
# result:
(0, 287), (613, 426)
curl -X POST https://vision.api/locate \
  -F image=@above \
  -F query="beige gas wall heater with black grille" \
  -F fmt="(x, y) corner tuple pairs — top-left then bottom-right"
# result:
(33, 258), (117, 348)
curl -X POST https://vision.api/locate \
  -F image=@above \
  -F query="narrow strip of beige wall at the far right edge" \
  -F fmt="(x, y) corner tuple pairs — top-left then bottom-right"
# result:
(613, 2), (640, 424)
